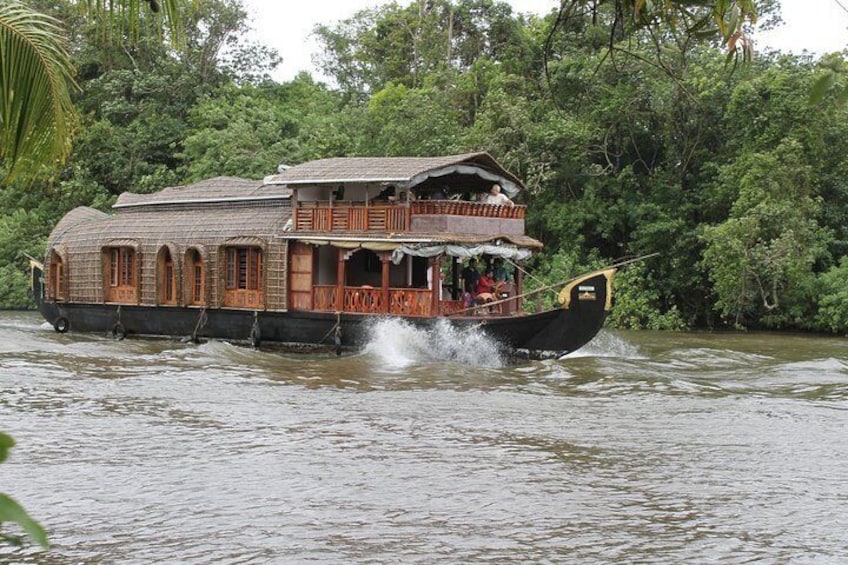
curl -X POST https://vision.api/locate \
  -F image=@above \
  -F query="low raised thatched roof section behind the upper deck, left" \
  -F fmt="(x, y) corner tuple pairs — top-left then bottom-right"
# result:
(114, 177), (291, 208)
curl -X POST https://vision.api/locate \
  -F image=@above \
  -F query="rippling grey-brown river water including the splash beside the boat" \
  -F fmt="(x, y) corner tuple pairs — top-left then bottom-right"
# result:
(0, 312), (848, 564)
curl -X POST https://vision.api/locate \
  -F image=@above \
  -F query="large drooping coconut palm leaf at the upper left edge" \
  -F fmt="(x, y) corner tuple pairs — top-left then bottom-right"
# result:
(0, 0), (76, 182)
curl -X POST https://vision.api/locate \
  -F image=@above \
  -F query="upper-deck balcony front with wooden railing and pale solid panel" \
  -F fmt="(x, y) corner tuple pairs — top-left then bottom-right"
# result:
(294, 200), (526, 235)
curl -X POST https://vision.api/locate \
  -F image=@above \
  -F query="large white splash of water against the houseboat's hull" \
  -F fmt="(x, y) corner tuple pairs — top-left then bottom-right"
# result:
(364, 318), (504, 368)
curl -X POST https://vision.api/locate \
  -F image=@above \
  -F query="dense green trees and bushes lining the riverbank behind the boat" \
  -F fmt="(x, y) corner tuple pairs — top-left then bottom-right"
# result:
(0, 0), (848, 334)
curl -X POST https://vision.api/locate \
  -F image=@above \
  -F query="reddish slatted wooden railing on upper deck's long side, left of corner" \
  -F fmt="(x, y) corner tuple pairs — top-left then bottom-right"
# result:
(294, 202), (409, 232)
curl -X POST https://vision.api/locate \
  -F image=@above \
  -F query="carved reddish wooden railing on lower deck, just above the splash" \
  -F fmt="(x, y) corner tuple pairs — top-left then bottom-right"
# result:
(312, 285), (433, 316)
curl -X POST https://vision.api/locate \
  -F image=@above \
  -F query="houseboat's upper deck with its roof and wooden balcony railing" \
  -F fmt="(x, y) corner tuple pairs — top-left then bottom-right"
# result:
(266, 153), (526, 235)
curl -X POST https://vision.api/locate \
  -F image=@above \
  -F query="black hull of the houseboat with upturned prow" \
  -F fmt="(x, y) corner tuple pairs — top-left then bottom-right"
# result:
(32, 269), (608, 357)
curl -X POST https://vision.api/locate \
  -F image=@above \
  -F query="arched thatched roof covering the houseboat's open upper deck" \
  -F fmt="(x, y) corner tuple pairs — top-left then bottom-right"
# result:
(266, 152), (524, 196)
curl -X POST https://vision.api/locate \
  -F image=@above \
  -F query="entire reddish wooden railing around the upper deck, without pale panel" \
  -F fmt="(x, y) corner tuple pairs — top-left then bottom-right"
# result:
(294, 200), (527, 232)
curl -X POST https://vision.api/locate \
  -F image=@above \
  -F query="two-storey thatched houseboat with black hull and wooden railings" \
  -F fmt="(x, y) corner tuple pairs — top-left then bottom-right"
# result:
(32, 153), (615, 356)
